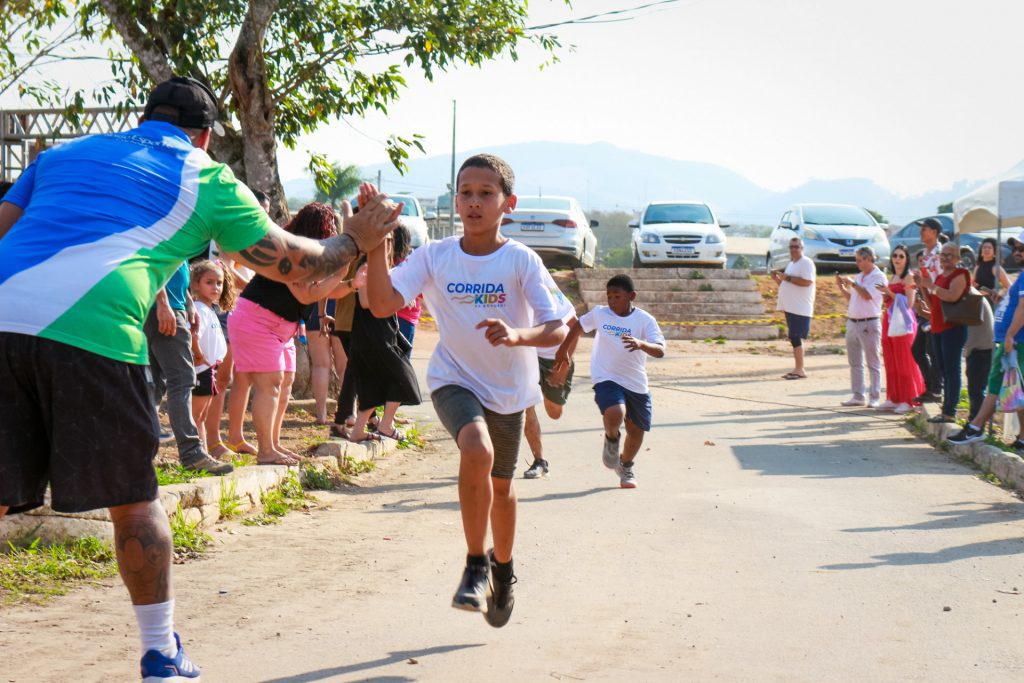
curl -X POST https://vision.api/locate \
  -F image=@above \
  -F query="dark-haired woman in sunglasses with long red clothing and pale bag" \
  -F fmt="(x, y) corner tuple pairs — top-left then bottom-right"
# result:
(878, 245), (925, 415)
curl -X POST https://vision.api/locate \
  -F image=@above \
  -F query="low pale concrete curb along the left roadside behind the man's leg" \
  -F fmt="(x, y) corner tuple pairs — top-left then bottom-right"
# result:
(0, 438), (397, 544)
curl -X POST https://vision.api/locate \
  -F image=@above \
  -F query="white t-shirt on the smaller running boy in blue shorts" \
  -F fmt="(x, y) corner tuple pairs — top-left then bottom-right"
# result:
(580, 306), (665, 393)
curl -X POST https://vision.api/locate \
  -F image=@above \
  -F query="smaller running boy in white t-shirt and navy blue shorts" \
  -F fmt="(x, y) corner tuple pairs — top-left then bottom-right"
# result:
(551, 274), (665, 488)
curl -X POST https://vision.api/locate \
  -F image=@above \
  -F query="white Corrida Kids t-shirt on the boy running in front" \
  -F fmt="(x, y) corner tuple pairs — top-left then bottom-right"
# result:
(391, 237), (571, 415)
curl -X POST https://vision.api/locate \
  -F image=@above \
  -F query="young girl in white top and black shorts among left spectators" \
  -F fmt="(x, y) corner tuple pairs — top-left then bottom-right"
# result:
(191, 260), (237, 453)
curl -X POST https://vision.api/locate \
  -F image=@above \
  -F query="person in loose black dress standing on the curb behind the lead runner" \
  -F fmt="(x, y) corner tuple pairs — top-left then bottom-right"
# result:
(348, 234), (420, 442)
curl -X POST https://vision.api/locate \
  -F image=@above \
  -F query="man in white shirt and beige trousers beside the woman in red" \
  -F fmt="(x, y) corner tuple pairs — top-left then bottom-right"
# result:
(836, 247), (888, 408)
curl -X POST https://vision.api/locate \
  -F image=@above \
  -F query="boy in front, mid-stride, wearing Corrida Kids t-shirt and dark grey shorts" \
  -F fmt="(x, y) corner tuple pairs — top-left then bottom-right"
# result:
(360, 155), (571, 627)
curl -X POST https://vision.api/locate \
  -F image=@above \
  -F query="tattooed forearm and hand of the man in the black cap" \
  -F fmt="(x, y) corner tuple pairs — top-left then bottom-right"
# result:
(222, 189), (401, 283)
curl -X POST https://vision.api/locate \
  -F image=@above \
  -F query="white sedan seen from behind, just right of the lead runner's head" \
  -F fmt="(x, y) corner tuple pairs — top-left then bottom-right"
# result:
(501, 195), (598, 268)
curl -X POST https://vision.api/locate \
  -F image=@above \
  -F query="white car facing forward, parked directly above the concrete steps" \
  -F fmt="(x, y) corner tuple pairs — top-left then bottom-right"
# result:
(629, 202), (728, 268)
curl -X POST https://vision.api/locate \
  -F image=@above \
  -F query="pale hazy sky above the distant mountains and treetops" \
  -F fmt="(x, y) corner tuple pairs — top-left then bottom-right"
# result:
(4, 0), (1024, 195)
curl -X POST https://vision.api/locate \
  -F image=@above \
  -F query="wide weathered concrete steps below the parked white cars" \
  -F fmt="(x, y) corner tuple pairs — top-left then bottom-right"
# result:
(575, 267), (778, 340)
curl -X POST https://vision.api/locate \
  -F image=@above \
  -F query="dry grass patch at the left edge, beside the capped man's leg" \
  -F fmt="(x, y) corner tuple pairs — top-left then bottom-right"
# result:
(0, 537), (118, 605)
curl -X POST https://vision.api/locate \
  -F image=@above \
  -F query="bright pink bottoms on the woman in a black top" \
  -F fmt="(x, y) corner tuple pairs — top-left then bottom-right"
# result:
(227, 297), (299, 373)
